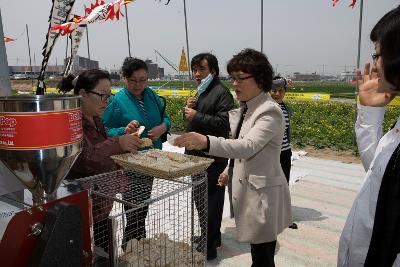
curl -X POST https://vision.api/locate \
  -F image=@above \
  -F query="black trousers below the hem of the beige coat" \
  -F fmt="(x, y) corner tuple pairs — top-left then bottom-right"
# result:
(250, 240), (276, 267)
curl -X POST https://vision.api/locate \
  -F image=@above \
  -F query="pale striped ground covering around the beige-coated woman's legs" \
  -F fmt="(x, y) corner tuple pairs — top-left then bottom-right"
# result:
(207, 157), (365, 267)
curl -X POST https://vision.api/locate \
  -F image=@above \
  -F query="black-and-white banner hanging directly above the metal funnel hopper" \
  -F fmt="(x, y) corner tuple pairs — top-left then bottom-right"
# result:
(38, 0), (75, 88)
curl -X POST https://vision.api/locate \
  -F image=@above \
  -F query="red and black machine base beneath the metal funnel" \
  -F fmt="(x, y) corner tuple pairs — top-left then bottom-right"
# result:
(0, 190), (92, 266)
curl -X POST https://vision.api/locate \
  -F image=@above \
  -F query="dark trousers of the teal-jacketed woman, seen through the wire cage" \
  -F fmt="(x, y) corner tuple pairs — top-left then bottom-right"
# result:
(122, 175), (154, 248)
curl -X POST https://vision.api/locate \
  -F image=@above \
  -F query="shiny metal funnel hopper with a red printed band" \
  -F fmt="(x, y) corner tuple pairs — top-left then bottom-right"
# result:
(0, 95), (83, 205)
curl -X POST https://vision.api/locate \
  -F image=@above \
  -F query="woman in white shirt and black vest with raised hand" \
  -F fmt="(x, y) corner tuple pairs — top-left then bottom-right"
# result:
(338, 6), (400, 266)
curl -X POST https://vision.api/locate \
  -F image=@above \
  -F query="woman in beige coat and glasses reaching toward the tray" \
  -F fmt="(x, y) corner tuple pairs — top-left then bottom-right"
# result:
(175, 49), (291, 267)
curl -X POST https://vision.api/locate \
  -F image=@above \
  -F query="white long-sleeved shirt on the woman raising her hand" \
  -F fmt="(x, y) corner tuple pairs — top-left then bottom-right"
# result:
(337, 105), (400, 267)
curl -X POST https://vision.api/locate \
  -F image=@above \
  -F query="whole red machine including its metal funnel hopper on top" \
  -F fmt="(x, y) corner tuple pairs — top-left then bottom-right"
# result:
(0, 95), (92, 266)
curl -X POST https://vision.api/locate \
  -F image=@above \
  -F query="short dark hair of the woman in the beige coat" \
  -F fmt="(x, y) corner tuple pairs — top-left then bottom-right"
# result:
(227, 48), (273, 92)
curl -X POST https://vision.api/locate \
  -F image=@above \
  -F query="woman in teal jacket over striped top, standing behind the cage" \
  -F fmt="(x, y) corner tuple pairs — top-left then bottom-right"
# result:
(103, 57), (171, 249)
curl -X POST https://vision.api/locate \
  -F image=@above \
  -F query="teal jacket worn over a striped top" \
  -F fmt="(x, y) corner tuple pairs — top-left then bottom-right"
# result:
(103, 87), (171, 149)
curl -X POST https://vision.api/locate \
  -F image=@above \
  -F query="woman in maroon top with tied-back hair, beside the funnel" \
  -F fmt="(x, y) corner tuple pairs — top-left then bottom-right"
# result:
(58, 69), (141, 180)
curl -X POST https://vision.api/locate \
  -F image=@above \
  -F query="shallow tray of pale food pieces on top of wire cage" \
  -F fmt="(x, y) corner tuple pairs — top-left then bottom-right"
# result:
(111, 149), (214, 179)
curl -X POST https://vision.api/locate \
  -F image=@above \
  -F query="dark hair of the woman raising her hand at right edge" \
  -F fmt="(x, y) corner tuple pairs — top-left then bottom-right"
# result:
(370, 6), (400, 91)
